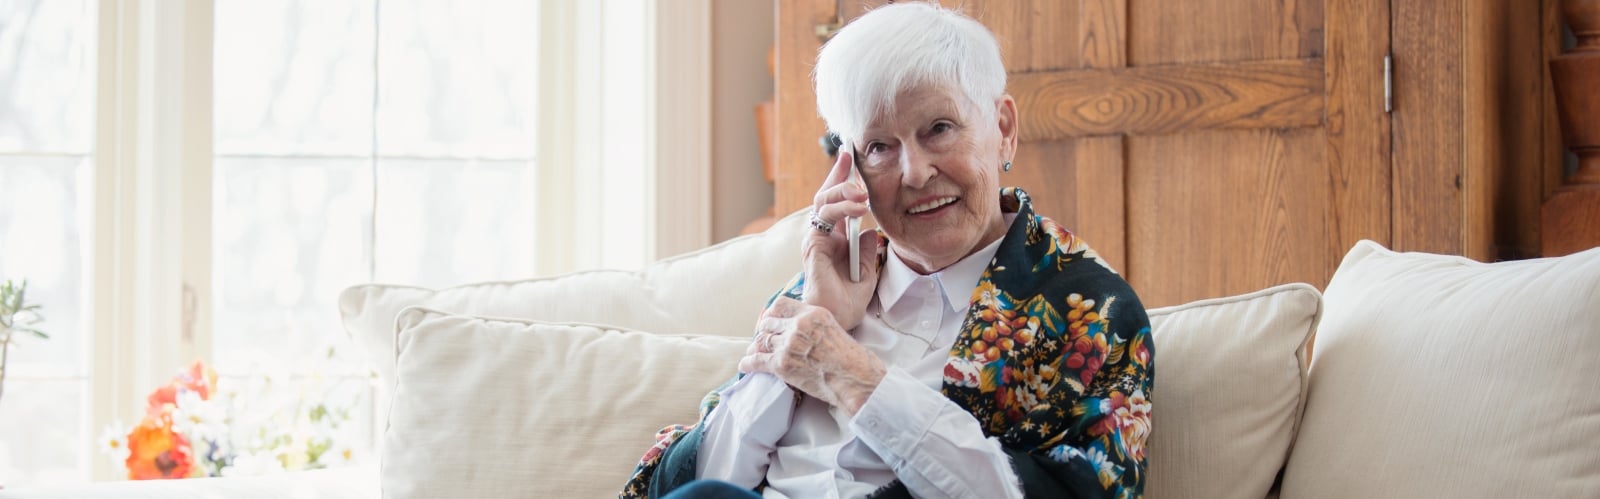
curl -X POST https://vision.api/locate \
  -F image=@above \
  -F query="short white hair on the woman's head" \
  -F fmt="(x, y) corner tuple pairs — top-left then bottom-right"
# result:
(811, 2), (1005, 142)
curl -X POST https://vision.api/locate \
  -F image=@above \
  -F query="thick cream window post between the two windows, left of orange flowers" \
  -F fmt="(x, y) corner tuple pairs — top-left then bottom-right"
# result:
(86, 0), (211, 480)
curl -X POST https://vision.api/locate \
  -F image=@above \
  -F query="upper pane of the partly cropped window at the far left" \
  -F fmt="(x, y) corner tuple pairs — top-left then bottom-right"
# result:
(0, 0), (94, 154)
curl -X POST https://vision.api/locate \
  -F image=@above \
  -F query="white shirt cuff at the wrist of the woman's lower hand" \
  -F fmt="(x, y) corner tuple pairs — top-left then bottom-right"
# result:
(850, 366), (949, 470)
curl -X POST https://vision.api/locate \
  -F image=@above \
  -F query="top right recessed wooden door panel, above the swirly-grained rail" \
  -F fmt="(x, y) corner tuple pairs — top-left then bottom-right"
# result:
(1128, 0), (1325, 66)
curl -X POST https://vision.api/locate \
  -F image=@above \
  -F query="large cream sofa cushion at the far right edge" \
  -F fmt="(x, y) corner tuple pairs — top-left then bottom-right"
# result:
(1283, 242), (1600, 497)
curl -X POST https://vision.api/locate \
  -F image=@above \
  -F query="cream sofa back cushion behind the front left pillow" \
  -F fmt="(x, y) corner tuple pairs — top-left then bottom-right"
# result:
(339, 207), (806, 384)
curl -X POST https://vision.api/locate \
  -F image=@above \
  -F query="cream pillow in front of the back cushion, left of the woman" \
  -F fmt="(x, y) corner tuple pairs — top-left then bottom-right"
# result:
(382, 307), (749, 497)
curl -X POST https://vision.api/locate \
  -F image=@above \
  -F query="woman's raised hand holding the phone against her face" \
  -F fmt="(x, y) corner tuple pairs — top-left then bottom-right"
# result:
(800, 142), (878, 331)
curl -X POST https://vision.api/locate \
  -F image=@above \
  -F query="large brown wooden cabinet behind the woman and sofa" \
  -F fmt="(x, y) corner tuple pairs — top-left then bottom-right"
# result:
(774, 0), (1560, 305)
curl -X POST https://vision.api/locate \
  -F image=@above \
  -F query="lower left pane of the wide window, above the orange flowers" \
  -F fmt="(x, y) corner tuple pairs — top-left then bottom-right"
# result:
(211, 157), (371, 373)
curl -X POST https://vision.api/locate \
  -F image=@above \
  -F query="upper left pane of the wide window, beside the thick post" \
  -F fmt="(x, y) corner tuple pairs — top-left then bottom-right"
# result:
(213, 0), (373, 155)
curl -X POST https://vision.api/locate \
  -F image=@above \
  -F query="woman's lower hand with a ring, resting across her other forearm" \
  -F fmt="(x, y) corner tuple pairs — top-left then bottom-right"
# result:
(739, 296), (886, 416)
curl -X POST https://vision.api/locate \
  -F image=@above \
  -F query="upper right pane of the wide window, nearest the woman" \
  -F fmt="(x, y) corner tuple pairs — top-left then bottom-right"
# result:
(378, 0), (539, 158)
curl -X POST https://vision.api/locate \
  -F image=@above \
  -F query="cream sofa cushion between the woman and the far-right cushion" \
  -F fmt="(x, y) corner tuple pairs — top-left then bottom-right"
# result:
(1146, 283), (1322, 499)
